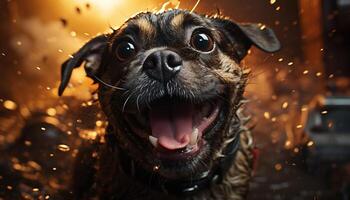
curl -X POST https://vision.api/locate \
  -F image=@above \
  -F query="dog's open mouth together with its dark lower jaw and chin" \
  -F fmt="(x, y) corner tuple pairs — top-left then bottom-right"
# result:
(113, 91), (228, 178)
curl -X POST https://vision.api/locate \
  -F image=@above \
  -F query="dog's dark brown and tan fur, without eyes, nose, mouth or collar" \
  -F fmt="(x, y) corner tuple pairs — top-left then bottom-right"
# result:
(59, 10), (279, 200)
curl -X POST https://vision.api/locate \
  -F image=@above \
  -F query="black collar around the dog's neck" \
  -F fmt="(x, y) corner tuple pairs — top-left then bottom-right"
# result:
(106, 134), (240, 196)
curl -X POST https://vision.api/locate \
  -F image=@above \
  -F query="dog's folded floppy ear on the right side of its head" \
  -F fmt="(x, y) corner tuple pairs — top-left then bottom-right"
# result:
(214, 18), (281, 60)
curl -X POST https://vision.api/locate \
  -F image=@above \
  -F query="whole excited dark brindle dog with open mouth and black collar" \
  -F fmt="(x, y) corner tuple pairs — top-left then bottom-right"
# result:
(59, 9), (280, 200)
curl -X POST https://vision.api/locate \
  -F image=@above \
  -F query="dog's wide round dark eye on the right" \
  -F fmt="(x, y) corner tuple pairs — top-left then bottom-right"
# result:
(191, 32), (214, 52)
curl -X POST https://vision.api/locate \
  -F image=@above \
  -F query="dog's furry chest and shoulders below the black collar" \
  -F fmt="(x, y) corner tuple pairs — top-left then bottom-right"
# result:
(85, 114), (253, 200)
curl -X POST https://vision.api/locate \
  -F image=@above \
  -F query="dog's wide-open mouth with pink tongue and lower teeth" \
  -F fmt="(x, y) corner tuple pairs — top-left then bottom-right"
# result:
(126, 97), (221, 160)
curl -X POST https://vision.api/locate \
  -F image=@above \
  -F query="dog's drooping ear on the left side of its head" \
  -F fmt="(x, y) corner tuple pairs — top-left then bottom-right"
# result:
(58, 35), (108, 96)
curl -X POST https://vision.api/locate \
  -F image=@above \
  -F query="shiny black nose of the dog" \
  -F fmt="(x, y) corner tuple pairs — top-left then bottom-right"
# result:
(143, 50), (182, 82)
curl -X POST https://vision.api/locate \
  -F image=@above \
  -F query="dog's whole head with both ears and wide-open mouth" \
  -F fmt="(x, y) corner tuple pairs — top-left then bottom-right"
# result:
(60, 10), (279, 178)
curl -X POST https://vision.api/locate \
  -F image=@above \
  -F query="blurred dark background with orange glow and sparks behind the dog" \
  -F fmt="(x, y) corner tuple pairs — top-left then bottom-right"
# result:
(0, 0), (350, 199)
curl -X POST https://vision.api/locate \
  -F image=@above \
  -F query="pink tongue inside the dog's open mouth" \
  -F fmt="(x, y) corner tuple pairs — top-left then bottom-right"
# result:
(150, 102), (193, 150)
